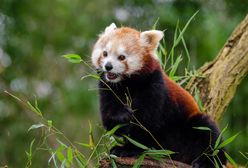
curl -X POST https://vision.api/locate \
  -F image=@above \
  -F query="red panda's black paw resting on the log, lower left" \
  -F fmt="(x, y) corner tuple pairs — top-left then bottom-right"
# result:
(110, 145), (143, 157)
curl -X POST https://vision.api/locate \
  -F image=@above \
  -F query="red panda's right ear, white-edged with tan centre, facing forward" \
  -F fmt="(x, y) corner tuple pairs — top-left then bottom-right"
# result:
(140, 30), (164, 50)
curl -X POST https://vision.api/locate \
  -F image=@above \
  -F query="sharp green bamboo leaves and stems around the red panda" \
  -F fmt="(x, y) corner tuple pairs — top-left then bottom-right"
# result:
(5, 13), (238, 168)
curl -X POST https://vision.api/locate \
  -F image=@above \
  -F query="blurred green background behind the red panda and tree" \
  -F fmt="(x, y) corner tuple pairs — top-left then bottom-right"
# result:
(0, 0), (248, 167)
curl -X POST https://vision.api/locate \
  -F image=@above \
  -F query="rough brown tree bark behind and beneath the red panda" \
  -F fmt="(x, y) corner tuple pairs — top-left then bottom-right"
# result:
(100, 15), (248, 168)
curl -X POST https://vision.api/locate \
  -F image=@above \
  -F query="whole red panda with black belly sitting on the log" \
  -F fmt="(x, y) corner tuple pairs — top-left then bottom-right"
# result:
(91, 23), (226, 168)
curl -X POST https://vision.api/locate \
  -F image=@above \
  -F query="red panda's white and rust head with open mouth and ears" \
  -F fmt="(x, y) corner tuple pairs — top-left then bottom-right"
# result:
(92, 24), (163, 83)
